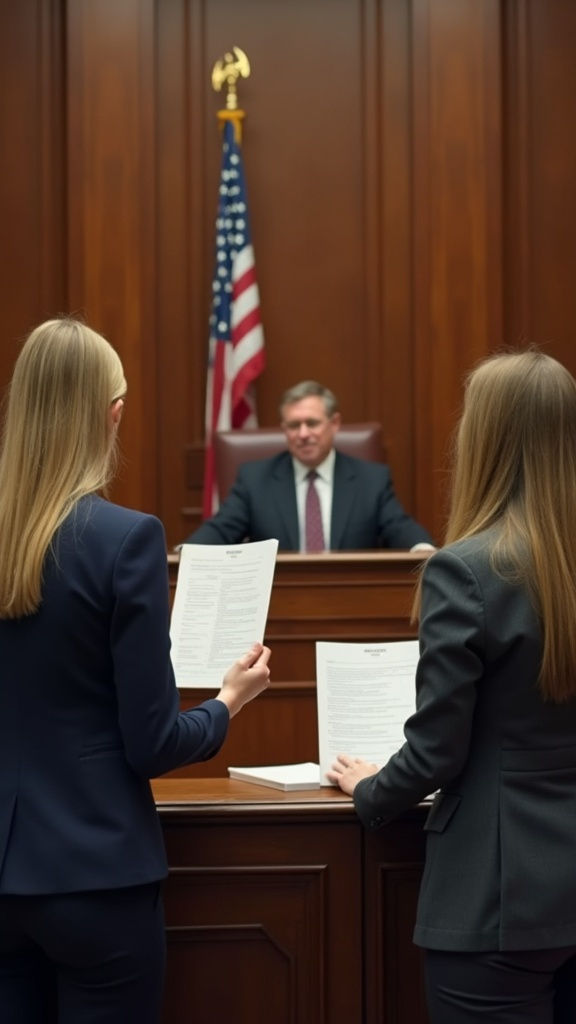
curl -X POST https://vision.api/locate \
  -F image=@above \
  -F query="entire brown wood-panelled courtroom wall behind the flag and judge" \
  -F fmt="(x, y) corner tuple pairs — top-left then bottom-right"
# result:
(0, 0), (576, 545)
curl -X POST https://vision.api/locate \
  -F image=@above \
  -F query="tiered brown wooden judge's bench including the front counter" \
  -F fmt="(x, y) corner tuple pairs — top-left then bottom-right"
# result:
(153, 552), (427, 1024)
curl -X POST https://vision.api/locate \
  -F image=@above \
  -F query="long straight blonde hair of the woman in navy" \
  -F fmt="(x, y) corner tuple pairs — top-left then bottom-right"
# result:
(0, 317), (126, 618)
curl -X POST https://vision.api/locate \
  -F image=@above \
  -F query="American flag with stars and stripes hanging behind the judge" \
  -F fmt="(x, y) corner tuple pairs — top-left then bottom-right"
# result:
(203, 121), (264, 517)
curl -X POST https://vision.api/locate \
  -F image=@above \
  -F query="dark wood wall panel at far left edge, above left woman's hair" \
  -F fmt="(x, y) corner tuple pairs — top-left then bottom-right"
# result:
(0, 0), (66, 380)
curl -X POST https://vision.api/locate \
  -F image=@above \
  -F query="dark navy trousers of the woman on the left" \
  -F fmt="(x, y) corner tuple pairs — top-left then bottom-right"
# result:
(0, 883), (166, 1024)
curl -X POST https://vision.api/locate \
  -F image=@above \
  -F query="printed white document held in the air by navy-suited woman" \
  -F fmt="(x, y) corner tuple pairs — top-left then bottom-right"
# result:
(170, 541), (278, 689)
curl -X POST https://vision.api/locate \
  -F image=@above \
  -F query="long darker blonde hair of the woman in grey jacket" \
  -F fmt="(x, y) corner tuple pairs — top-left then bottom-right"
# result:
(414, 349), (576, 701)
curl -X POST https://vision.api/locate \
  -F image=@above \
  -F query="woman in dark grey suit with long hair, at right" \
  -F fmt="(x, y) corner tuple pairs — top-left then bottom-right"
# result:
(329, 350), (576, 1024)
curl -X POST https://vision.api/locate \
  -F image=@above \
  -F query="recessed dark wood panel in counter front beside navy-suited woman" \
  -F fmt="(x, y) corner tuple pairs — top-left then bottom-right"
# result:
(166, 858), (328, 1024)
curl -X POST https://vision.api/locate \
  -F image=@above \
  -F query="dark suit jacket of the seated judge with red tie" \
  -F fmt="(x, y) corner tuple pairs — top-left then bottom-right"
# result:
(187, 452), (434, 551)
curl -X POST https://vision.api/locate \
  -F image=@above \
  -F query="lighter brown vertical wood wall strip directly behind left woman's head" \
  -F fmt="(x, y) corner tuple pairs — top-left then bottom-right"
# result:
(67, 0), (156, 512)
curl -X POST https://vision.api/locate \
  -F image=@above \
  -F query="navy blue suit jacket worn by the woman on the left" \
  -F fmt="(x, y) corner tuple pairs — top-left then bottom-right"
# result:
(0, 498), (229, 894)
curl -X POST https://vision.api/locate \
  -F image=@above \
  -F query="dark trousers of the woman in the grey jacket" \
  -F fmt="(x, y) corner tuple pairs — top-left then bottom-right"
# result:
(424, 946), (576, 1024)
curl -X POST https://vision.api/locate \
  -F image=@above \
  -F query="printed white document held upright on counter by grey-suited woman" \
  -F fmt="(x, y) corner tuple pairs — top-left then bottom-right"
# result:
(316, 640), (418, 785)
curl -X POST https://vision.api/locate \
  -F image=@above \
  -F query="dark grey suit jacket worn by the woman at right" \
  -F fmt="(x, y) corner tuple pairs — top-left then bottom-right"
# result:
(351, 534), (576, 951)
